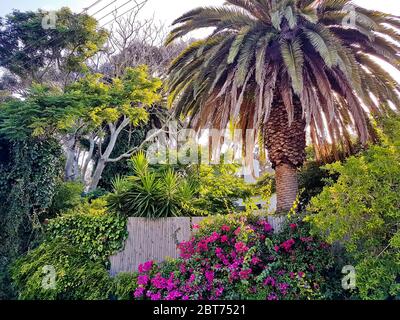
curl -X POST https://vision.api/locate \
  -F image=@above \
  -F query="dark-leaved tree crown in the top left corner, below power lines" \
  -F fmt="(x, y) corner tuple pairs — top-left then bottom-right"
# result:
(0, 8), (108, 90)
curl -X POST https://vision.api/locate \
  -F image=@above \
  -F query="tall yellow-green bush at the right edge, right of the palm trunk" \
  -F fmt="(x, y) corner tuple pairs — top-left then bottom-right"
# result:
(309, 119), (400, 299)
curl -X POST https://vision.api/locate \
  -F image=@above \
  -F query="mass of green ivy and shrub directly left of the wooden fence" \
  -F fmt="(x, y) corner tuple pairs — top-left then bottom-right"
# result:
(12, 198), (127, 300)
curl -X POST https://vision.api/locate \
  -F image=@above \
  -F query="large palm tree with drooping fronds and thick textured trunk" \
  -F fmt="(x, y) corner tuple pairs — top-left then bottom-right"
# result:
(167, 0), (400, 212)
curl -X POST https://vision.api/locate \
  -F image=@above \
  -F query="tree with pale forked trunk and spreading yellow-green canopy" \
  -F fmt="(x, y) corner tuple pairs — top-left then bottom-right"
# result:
(0, 66), (161, 190)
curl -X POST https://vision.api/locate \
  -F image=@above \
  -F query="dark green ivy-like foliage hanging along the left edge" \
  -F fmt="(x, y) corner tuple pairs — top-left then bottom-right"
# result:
(0, 139), (63, 300)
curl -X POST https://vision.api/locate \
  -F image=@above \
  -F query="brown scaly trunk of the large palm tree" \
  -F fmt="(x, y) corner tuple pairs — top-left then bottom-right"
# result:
(265, 96), (306, 213)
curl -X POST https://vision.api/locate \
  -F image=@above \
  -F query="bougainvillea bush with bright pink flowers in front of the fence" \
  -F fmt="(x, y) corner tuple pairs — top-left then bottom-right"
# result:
(133, 214), (340, 300)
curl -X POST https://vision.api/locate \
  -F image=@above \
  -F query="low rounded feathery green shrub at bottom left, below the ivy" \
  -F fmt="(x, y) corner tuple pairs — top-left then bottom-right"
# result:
(11, 239), (110, 300)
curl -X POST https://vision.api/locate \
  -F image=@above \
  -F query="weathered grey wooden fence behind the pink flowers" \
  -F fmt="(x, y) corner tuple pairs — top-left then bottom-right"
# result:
(110, 217), (285, 276)
